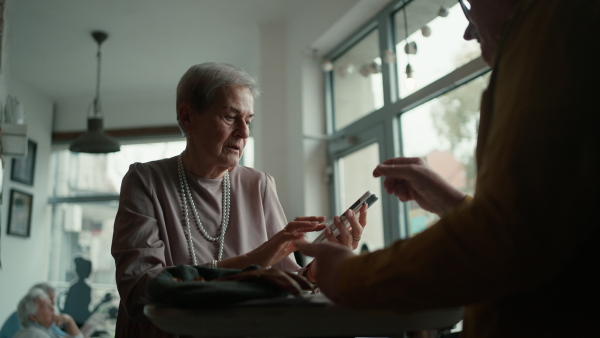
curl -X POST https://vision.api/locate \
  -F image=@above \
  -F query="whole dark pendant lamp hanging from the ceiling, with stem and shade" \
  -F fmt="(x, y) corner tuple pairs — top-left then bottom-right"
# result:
(69, 31), (121, 154)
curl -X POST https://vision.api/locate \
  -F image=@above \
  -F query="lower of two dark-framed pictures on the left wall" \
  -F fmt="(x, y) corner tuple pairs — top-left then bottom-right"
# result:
(6, 189), (33, 237)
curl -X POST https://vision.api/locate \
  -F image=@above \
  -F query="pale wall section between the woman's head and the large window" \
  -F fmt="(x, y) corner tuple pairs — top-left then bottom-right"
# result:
(257, 0), (380, 220)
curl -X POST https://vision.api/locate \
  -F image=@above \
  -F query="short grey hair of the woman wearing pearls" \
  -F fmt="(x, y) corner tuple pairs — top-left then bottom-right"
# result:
(176, 62), (260, 137)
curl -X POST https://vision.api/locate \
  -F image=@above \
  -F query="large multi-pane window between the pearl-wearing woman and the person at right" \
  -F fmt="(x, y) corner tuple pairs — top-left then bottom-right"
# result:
(325, 0), (489, 249)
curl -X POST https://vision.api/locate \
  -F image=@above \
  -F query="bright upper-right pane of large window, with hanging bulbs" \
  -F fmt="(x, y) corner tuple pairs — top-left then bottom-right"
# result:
(394, 0), (481, 98)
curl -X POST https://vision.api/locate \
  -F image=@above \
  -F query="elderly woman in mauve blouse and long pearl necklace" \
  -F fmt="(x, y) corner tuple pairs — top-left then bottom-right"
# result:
(112, 63), (366, 337)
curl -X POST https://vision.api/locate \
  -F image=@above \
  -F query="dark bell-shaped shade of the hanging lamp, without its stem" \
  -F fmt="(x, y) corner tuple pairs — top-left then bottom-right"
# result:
(69, 117), (121, 154)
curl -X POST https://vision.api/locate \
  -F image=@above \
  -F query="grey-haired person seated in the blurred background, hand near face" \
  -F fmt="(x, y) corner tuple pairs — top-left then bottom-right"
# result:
(14, 288), (83, 338)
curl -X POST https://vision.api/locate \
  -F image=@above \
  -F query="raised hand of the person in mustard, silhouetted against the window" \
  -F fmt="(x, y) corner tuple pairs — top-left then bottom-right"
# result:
(373, 157), (466, 215)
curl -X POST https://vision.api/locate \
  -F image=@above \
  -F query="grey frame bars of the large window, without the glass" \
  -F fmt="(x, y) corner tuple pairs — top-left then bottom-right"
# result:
(323, 0), (490, 245)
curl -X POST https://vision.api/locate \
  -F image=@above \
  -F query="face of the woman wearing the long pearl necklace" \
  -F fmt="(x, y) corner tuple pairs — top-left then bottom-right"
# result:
(185, 87), (254, 178)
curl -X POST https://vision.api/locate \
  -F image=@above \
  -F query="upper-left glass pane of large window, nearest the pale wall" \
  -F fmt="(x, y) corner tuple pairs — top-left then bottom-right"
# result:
(333, 29), (383, 129)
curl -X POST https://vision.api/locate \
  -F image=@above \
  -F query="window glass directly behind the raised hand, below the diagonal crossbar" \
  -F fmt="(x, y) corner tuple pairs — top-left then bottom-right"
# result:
(400, 74), (489, 235)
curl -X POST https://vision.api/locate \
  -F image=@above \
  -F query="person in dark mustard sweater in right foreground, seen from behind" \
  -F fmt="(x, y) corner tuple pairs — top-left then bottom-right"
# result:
(297, 0), (600, 338)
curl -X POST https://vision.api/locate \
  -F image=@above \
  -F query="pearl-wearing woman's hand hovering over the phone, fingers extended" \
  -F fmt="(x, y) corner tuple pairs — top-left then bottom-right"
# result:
(246, 216), (326, 267)
